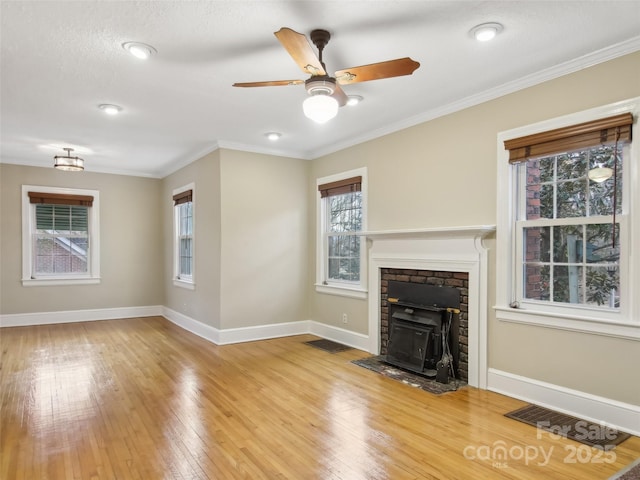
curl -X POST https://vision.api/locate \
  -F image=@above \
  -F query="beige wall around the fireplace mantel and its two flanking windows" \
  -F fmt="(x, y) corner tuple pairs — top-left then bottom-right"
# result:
(308, 53), (640, 404)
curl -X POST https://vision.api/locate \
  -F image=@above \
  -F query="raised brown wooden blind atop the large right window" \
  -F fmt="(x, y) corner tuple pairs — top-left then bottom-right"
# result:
(504, 113), (633, 163)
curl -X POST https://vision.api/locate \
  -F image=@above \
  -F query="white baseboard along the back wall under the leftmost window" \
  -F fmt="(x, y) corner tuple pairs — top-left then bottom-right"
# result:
(0, 305), (162, 327)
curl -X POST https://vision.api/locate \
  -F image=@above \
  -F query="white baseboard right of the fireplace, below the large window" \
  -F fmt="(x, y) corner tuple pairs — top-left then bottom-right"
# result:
(487, 368), (640, 436)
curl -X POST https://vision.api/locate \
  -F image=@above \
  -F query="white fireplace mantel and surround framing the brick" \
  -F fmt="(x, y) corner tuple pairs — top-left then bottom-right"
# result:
(362, 225), (496, 389)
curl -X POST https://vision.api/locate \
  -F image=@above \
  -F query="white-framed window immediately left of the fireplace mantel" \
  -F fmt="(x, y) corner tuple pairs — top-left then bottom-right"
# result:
(316, 169), (366, 298)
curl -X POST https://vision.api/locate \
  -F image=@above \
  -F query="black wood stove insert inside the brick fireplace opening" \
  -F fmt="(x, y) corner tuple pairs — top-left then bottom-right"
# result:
(386, 280), (460, 383)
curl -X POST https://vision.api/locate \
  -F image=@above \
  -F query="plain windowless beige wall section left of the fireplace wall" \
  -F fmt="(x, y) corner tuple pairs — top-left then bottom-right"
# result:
(221, 150), (310, 329)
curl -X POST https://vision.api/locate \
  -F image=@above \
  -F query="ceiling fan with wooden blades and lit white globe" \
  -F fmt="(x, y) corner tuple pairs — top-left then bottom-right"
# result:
(233, 27), (420, 123)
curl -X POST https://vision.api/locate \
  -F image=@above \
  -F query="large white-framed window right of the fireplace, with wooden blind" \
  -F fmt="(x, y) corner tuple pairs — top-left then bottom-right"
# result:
(496, 99), (640, 338)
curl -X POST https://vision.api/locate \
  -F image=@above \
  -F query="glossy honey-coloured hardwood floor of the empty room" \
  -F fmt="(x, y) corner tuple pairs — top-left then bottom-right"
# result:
(0, 317), (640, 480)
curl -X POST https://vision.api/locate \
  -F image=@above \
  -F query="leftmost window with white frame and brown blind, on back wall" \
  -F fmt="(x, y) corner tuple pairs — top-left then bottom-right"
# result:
(22, 185), (100, 286)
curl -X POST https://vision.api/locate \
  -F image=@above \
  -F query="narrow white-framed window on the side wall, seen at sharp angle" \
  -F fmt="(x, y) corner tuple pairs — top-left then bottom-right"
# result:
(173, 185), (194, 288)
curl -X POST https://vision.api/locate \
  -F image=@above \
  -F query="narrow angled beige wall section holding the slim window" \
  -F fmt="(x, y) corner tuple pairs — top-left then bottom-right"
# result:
(160, 151), (221, 329)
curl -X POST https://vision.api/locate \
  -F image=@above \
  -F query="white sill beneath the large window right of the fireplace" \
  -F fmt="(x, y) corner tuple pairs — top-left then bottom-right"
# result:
(493, 306), (640, 341)
